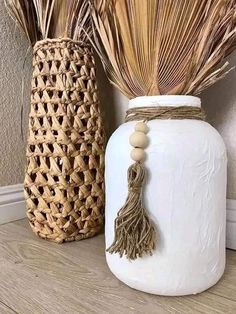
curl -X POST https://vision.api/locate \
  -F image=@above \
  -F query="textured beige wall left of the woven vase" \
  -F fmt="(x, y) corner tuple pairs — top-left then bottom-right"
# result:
(0, 0), (31, 186)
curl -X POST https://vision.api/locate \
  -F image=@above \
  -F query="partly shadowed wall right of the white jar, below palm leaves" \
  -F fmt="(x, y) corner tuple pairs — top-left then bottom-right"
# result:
(202, 53), (236, 199)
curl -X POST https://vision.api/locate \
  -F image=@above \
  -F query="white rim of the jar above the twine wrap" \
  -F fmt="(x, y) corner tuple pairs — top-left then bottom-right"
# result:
(129, 95), (201, 109)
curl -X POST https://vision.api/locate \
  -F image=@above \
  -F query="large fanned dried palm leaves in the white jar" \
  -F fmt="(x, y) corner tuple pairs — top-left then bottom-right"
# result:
(91, 0), (236, 98)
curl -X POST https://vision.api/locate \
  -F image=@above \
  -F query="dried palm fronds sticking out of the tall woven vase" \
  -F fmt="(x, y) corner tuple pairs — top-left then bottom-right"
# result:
(5, 0), (92, 45)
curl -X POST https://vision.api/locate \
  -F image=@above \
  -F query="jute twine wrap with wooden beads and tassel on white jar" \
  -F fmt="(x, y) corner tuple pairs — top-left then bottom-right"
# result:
(107, 106), (206, 260)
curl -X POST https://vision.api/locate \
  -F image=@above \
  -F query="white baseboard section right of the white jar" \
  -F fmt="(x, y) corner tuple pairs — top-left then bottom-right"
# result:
(226, 199), (236, 250)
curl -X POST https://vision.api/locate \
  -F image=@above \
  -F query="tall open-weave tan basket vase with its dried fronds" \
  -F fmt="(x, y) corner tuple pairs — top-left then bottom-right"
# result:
(6, 0), (104, 243)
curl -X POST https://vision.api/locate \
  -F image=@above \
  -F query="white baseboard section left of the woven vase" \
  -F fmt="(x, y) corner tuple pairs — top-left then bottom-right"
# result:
(0, 184), (26, 225)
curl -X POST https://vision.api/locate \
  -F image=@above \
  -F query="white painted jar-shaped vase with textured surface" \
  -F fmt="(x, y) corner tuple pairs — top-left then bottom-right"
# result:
(105, 96), (227, 296)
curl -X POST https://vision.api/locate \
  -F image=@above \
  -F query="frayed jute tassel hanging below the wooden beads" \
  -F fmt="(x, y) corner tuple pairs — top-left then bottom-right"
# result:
(107, 162), (156, 260)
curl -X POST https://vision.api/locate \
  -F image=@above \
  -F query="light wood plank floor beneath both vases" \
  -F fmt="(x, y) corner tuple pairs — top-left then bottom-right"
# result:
(0, 220), (236, 314)
